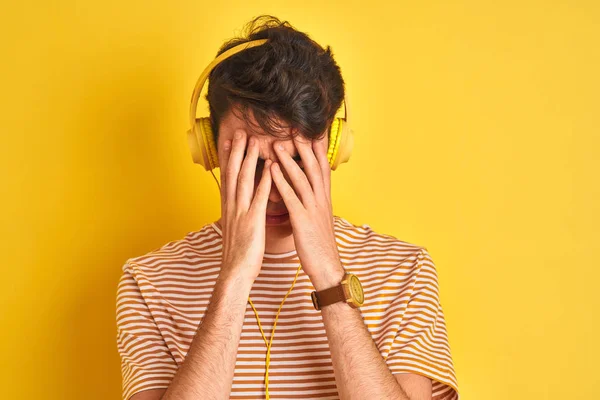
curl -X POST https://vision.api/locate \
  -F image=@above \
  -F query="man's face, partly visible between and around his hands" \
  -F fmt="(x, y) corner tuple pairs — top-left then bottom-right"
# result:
(217, 110), (328, 236)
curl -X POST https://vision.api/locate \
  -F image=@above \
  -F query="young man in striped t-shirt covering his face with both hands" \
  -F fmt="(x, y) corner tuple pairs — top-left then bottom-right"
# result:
(117, 16), (458, 400)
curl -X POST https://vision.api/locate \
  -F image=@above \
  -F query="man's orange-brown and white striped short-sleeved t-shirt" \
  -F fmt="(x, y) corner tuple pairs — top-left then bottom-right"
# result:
(116, 216), (458, 400)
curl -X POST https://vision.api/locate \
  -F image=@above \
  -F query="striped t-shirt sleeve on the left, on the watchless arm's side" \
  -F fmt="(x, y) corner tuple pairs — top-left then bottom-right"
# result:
(116, 263), (177, 400)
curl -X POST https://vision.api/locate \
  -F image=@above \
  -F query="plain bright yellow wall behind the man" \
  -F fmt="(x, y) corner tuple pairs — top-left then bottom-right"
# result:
(0, 0), (600, 400)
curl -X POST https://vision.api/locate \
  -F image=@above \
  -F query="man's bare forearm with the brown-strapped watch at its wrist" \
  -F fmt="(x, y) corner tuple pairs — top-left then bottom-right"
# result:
(313, 267), (410, 400)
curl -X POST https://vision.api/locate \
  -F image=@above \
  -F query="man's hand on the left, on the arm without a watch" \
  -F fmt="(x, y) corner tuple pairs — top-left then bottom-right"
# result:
(220, 130), (271, 282)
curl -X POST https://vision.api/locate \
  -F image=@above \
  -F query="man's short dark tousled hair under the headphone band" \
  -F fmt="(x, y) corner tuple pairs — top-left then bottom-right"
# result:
(206, 15), (344, 143)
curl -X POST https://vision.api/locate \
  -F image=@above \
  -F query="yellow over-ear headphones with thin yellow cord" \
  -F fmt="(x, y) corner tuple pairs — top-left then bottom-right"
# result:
(187, 39), (354, 400)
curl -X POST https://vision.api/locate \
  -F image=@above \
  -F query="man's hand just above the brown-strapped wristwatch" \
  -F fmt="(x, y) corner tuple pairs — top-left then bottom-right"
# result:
(271, 135), (344, 290)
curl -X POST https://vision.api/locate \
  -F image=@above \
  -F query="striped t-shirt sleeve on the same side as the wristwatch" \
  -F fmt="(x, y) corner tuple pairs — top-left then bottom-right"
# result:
(386, 248), (459, 400)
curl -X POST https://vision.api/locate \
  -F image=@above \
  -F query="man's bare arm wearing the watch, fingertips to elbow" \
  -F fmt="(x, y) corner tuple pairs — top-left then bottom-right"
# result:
(272, 135), (431, 400)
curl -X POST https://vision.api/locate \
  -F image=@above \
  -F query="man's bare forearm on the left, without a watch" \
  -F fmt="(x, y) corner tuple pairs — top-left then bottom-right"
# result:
(162, 274), (252, 400)
